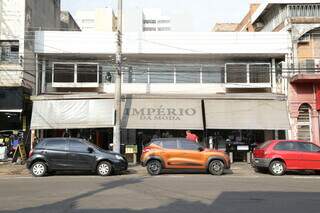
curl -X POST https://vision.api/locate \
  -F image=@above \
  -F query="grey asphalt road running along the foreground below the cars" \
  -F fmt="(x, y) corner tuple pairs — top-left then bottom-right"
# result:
(0, 168), (320, 213)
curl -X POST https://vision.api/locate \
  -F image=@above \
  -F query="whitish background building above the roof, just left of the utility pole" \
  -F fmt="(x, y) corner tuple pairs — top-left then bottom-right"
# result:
(76, 8), (117, 32)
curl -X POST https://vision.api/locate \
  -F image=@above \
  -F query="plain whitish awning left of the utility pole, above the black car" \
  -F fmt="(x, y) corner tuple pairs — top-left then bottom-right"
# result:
(31, 99), (114, 129)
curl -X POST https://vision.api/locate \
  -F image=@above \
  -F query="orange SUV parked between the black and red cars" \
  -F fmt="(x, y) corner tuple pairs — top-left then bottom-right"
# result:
(140, 138), (230, 175)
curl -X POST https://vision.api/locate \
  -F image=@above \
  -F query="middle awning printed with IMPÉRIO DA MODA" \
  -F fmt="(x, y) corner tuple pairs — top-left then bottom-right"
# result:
(121, 99), (203, 130)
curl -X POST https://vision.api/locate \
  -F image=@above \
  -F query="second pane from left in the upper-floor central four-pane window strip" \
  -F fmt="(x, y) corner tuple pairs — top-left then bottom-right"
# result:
(149, 65), (174, 83)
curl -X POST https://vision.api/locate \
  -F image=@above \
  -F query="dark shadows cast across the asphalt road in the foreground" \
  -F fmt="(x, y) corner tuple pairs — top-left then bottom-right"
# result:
(3, 190), (320, 213)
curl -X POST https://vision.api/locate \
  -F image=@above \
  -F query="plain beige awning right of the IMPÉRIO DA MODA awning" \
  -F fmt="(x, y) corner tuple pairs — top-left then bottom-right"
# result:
(205, 100), (290, 130)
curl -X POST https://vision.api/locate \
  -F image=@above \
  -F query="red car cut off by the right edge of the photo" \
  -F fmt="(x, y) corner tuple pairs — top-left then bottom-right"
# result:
(252, 140), (320, 175)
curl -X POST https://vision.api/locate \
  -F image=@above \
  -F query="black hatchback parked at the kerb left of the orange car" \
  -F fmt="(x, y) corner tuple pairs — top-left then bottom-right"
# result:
(27, 138), (128, 177)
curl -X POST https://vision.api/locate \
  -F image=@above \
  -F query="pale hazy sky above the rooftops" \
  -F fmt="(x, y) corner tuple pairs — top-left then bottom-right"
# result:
(61, 0), (265, 32)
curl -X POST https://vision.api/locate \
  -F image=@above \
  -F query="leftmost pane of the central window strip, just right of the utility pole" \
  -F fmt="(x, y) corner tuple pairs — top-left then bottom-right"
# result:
(123, 66), (148, 84)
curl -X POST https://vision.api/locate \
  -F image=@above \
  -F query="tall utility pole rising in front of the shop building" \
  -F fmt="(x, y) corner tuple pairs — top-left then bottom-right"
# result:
(113, 0), (122, 153)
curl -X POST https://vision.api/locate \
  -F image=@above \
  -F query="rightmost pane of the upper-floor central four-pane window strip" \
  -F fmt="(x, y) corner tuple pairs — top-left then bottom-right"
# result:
(202, 66), (224, 83)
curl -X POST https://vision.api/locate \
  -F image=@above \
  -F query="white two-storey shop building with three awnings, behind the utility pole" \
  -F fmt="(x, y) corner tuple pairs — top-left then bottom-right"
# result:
(31, 31), (289, 160)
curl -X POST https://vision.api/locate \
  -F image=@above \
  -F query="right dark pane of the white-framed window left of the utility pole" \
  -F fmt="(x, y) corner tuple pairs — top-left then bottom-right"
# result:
(77, 64), (98, 83)
